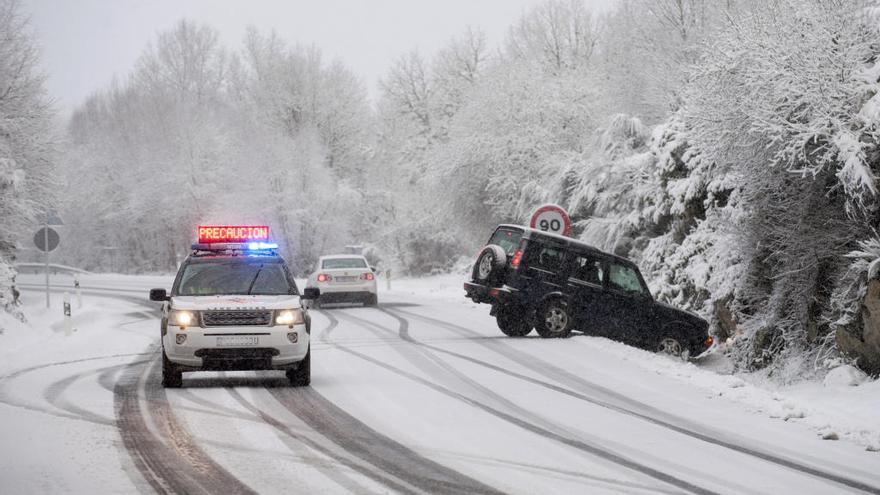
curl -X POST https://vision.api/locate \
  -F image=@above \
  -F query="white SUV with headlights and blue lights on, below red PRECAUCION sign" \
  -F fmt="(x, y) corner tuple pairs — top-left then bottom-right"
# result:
(150, 244), (320, 387)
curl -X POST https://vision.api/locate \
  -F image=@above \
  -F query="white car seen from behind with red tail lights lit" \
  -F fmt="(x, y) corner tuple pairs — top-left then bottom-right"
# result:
(306, 254), (379, 306)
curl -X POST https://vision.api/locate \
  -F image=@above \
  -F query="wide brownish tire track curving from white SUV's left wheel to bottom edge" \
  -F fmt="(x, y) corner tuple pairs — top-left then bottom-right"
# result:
(114, 351), (254, 494)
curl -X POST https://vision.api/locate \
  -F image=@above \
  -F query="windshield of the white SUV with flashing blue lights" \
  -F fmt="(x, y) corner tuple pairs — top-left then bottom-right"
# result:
(177, 259), (296, 296)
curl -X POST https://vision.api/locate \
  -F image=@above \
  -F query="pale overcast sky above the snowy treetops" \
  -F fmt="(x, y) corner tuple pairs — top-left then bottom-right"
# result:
(23, 0), (615, 114)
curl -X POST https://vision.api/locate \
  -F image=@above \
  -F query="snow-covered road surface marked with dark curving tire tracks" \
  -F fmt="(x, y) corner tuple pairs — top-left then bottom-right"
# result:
(0, 276), (880, 495)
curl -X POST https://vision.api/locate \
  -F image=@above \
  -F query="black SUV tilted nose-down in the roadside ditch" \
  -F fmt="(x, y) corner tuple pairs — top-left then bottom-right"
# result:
(464, 225), (712, 358)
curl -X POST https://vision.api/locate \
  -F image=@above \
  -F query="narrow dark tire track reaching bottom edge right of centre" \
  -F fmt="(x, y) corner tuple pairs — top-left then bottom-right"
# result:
(323, 312), (716, 495)
